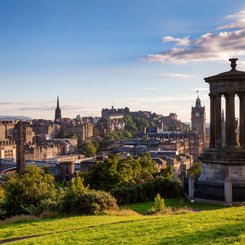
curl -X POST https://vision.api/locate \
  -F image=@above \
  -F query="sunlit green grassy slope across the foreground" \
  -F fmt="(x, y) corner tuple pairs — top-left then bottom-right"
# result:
(0, 204), (245, 245)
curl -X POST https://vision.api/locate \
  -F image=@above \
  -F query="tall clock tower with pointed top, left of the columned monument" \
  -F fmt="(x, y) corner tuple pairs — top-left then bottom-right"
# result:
(191, 95), (206, 142)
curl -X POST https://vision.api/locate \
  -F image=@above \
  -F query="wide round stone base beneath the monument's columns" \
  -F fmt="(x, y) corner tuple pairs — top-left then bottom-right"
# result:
(194, 147), (245, 205)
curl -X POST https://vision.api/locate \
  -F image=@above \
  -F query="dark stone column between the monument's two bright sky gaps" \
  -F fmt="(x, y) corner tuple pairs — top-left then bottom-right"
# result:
(225, 93), (235, 147)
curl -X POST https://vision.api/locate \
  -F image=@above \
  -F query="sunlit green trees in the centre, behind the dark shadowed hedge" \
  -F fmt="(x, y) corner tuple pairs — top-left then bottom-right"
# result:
(87, 154), (156, 191)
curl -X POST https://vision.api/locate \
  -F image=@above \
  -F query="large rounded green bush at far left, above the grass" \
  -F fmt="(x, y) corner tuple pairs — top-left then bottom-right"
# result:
(2, 166), (57, 216)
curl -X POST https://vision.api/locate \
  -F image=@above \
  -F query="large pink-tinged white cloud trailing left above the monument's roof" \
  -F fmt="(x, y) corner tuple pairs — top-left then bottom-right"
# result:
(146, 10), (245, 63)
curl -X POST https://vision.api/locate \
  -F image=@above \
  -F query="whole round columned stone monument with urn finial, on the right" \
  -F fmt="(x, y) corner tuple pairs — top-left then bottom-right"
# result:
(193, 58), (245, 205)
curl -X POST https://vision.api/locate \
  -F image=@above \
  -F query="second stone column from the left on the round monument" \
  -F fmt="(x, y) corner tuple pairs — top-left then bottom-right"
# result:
(215, 94), (222, 146)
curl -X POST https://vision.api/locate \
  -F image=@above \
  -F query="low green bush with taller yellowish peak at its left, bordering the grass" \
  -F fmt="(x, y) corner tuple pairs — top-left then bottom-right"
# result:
(61, 176), (117, 214)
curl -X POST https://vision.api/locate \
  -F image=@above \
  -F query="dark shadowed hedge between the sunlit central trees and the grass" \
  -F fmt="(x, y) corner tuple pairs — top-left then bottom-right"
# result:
(110, 177), (181, 205)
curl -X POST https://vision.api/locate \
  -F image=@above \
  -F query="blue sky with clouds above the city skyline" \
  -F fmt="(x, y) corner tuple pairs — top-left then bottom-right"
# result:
(0, 0), (245, 122)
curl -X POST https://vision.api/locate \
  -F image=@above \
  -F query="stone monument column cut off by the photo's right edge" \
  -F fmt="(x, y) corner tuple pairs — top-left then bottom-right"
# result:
(238, 93), (245, 148)
